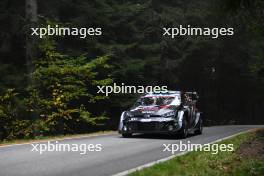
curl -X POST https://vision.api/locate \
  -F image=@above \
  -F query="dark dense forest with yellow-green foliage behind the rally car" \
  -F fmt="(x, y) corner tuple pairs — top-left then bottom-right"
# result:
(0, 0), (264, 140)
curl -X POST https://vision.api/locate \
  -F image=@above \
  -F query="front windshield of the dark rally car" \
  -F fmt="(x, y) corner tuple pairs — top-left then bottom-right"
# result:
(135, 97), (174, 107)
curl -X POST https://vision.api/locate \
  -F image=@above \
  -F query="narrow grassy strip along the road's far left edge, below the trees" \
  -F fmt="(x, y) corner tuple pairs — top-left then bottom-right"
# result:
(0, 131), (114, 146)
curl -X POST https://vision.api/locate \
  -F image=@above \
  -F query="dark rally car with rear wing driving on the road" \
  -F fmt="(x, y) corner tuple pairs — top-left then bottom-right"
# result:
(118, 91), (203, 138)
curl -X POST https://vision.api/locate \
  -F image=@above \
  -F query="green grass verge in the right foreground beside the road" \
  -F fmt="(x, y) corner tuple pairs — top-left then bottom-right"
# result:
(130, 130), (264, 176)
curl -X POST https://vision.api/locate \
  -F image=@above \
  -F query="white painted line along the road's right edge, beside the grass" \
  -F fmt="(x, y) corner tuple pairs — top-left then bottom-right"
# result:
(111, 128), (259, 176)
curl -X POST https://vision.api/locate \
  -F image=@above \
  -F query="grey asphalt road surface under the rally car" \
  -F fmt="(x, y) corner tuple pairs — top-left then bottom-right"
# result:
(0, 125), (264, 176)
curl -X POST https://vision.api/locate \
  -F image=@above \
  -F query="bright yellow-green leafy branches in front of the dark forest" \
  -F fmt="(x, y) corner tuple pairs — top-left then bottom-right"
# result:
(28, 39), (112, 133)
